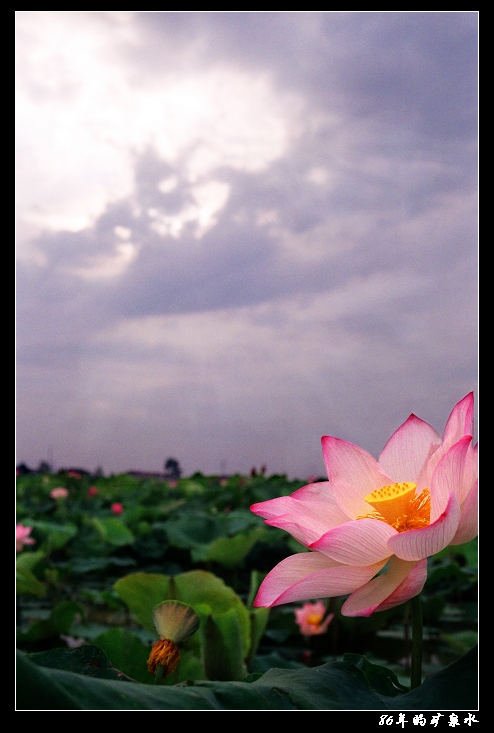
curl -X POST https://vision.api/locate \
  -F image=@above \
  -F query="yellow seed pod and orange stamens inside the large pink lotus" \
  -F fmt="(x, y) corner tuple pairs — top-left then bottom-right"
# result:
(359, 481), (431, 532)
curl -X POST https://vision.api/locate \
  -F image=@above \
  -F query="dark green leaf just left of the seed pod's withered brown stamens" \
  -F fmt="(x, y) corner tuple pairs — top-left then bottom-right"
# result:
(92, 628), (153, 683)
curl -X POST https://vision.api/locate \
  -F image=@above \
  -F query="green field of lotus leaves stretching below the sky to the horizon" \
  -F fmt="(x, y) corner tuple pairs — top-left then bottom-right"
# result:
(16, 472), (477, 710)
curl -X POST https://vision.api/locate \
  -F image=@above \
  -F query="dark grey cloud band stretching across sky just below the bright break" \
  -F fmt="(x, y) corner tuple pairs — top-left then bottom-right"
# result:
(19, 126), (474, 330)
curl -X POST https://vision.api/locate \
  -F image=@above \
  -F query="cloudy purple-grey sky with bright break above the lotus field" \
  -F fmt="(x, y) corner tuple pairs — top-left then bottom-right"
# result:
(16, 11), (478, 479)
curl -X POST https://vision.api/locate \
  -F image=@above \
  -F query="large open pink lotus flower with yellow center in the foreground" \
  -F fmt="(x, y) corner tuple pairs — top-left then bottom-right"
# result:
(251, 393), (478, 616)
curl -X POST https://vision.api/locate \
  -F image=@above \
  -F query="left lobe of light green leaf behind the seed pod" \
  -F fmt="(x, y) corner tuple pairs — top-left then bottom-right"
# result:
(113, 573), (172, 634)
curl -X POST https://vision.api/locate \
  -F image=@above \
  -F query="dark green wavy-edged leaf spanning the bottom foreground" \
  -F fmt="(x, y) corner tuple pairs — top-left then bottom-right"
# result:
(17, 649), (478, 708)
